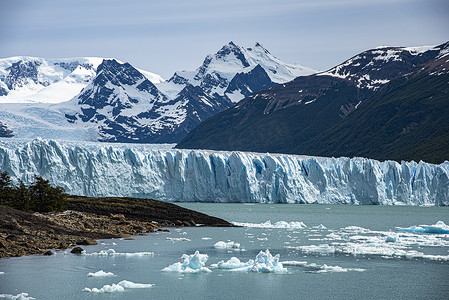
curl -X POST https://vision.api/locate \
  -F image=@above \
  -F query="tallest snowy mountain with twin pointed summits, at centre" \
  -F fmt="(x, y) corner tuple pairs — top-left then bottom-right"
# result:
(160, 42), (318, 102)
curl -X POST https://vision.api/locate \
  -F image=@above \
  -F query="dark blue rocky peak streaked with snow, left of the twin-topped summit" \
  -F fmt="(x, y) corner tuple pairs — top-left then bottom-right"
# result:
(65, 60), (230, 143)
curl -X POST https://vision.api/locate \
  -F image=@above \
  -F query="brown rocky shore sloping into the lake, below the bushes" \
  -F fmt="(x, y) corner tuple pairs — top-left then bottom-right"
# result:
(0, 196), (232, 258)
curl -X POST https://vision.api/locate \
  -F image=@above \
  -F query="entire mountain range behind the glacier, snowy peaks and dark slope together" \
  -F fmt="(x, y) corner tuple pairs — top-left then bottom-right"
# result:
(0, 42), (449, 163)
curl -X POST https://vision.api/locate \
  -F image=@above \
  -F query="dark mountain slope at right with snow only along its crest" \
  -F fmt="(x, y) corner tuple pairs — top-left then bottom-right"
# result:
(177, 42), (449, 163)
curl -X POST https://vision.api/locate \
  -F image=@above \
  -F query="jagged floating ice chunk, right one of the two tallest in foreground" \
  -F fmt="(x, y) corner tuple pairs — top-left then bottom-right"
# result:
(212, 249), (287, 273)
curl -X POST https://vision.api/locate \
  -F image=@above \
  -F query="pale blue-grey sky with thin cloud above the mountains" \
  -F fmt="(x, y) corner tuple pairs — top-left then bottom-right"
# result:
(0, 0), (449, 79)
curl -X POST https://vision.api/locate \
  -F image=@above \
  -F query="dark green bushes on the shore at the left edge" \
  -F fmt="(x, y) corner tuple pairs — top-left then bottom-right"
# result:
(0, 172), (68, 212)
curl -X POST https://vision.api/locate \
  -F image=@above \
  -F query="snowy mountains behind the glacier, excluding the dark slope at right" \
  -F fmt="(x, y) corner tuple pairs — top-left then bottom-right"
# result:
(0, 42), (317, 143)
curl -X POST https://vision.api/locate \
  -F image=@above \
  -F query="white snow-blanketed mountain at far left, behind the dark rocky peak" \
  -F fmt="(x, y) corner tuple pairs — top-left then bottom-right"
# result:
(0, 56), (163, 103)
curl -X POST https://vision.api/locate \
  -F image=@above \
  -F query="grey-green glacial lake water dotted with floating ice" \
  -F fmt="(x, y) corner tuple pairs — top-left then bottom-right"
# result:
(0, 203), (449, 299)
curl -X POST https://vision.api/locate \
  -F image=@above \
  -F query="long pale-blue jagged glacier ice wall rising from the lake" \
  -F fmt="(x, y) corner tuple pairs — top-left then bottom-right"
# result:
(0, 139), (449, 206)
